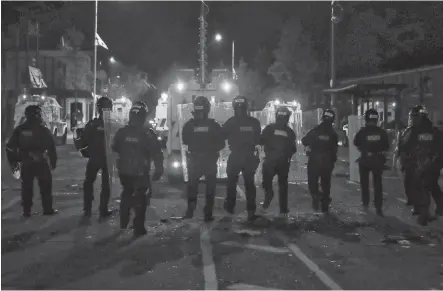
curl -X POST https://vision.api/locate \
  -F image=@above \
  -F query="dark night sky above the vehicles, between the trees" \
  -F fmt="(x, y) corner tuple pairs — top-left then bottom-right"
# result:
(2, 1), (329, 82)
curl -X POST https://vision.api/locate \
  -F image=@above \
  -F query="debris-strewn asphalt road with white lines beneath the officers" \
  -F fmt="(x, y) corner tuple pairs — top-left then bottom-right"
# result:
(1, 145), (443, 290)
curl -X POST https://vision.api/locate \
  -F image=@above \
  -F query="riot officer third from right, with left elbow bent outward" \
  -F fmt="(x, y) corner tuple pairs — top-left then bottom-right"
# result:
(302, 109), (338, 212)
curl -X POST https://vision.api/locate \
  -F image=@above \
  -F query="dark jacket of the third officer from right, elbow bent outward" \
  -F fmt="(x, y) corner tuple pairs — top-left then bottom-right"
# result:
(301, 123), (338, 161)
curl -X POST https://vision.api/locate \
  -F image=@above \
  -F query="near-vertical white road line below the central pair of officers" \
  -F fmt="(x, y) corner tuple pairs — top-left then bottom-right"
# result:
(200, 224), (218, 290)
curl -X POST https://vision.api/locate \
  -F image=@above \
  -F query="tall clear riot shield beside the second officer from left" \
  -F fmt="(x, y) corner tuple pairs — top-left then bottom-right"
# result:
(102, 109), (118, 197)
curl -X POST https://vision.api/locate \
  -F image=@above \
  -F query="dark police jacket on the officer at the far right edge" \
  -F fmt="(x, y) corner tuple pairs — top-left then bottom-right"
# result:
(398, 120), (443, 166)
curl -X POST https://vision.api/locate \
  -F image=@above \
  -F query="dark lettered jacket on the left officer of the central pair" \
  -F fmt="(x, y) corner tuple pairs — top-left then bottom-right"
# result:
(182, 118), (225, 154)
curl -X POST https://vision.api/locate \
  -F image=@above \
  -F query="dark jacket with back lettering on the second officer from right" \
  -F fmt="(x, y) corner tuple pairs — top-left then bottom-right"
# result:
(354, 126), (389, 156)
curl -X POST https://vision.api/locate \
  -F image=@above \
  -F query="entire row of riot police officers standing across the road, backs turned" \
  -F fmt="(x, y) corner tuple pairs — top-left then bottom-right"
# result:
(6, 96), (443, 235)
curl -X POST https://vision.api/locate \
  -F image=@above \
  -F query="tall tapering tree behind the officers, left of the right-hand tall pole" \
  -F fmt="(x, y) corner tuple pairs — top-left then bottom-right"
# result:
(269, 18), (321, 101)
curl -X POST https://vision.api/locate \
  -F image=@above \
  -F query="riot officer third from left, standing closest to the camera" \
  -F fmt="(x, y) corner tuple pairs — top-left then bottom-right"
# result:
(112, 103), (163, 236)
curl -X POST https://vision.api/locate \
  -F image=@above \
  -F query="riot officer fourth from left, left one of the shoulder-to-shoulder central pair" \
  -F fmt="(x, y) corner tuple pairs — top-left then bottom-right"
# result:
(182, 96), (225, 222)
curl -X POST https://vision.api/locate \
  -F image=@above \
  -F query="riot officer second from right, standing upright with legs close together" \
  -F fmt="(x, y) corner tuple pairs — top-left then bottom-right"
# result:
(354, 108), (389, 216)
